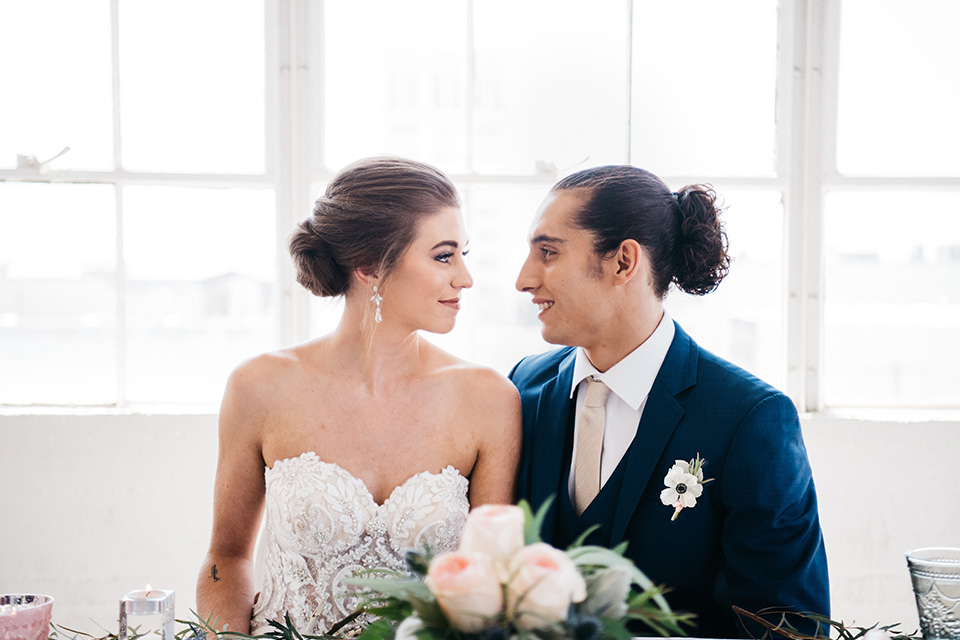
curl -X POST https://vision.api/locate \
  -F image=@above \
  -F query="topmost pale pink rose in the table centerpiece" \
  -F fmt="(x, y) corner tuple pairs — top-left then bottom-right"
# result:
(460, 504), (523, 568)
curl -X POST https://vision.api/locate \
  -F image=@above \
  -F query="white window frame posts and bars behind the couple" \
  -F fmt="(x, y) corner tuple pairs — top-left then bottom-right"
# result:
(0, 0), (960, 412)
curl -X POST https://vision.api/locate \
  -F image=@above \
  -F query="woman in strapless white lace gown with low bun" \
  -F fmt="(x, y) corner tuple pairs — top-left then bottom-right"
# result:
(197, 157), (520, 634)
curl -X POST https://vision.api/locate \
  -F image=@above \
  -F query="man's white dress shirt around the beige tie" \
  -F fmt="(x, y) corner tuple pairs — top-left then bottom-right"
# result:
(567, 311), (675, 499)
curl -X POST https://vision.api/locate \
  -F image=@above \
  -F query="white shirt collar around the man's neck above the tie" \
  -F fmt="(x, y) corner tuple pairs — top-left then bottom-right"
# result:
(570, 311), (676, 411)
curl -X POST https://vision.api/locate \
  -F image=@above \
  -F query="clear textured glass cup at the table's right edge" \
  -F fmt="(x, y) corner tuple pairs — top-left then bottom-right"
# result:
(907, 547), (960, 640)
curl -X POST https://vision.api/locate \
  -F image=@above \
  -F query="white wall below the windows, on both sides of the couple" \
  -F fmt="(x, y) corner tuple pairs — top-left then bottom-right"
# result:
(0, 414), (960, 634)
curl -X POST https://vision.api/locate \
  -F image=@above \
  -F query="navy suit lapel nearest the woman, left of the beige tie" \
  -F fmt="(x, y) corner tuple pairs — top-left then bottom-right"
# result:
(530, 350), (576, 531)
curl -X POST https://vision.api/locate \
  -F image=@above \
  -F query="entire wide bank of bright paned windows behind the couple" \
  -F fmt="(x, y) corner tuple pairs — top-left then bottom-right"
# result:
(0, 0), (960, 410)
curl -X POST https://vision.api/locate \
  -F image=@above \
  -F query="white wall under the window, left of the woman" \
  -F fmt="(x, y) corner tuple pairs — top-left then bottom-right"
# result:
(0, 415), (217, 635)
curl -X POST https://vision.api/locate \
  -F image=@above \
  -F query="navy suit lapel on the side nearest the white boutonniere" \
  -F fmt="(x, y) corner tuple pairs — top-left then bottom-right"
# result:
(610, 325), (697, 545)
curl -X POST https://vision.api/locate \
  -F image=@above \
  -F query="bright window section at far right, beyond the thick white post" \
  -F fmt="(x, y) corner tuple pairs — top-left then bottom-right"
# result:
(823, 0), (960, 407)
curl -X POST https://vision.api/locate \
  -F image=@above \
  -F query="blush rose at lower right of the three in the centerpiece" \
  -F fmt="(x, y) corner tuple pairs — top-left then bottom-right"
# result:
(507, 542), (587, 629)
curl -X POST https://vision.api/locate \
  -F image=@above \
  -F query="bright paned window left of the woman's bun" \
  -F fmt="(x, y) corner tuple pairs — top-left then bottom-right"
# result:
(0, 0), (277, 406)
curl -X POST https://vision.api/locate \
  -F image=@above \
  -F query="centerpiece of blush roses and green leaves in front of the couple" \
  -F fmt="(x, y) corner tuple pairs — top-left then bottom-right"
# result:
(344, 503), (692, 640)
